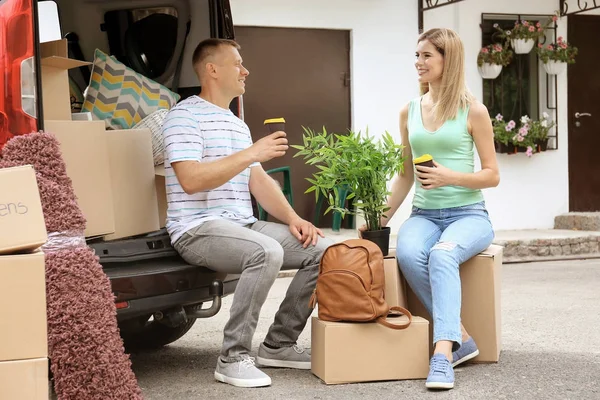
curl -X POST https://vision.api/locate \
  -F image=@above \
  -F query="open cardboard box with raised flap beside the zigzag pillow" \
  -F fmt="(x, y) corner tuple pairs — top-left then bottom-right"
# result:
(40, 39), (91, 121)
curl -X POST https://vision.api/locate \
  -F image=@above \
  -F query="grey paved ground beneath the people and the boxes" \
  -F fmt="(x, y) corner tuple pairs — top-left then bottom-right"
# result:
(132, 260), (600, 400)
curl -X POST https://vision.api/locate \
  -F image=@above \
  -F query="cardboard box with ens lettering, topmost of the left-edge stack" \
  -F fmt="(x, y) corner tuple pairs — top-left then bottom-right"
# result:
(0, 165), (48, 253)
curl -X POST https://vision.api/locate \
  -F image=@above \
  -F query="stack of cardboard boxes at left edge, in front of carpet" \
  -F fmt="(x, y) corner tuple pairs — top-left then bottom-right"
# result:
(0, 166), (48, 400)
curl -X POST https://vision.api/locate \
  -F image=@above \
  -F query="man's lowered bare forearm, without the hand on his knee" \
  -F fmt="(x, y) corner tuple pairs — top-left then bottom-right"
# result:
(250, 165), (300, 225)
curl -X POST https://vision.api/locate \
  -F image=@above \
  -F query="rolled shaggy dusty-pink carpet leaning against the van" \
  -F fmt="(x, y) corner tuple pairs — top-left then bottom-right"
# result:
(0, 133), (142, 400)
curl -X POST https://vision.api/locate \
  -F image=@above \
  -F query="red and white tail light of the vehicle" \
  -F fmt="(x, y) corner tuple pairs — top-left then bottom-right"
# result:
(0, 0), (38, 149)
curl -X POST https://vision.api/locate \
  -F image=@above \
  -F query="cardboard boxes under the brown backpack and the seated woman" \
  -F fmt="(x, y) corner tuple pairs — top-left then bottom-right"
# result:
(311, 245), (502, 384)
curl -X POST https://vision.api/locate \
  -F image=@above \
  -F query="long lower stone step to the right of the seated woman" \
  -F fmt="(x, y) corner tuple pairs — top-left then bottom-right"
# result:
(494, 229), (600, 263)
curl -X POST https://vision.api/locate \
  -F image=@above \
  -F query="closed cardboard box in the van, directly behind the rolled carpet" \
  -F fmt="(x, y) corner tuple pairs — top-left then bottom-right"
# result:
(45, 121), (115, 237)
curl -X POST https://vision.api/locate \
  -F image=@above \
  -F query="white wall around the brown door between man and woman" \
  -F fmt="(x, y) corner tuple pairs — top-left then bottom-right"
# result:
(231, 0), (419, 232)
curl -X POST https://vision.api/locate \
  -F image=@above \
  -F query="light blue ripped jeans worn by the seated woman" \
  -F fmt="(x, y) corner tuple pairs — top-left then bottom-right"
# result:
(396, 202), (494, 351)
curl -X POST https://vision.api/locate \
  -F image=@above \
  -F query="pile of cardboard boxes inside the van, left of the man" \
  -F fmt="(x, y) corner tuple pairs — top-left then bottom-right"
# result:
(40, 40), (161, 240)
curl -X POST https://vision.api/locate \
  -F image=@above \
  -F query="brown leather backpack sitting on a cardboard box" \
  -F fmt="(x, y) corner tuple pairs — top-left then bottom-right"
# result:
(309, 239), (412, 329)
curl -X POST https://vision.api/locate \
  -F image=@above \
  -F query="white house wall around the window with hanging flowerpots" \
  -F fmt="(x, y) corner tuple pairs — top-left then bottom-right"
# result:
(424, 0), (569, 230)
